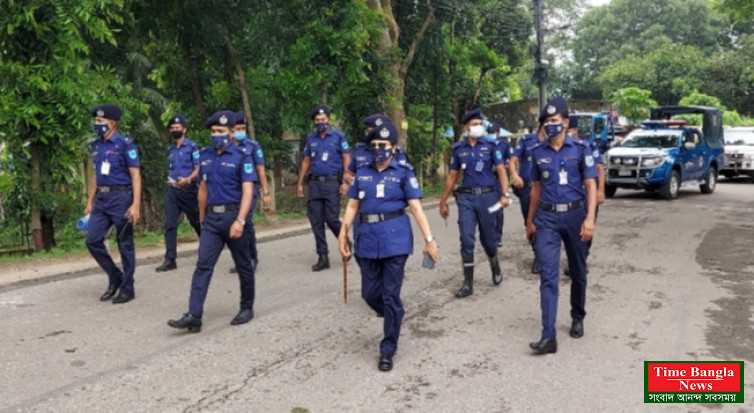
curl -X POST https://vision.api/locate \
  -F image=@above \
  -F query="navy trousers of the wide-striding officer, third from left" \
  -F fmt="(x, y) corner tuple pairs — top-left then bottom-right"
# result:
(189, 211), (254, 318)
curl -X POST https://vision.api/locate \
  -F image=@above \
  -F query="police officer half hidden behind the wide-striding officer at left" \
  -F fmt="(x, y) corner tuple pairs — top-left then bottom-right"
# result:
(231, 111), (272, 273)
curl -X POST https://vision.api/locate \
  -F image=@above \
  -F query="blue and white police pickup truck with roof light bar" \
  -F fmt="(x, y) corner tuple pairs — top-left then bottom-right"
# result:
(605, 106), (724, 199)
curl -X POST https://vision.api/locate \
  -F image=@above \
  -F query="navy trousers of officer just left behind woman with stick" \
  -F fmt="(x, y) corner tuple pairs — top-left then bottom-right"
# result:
(306, 181), (341, 255)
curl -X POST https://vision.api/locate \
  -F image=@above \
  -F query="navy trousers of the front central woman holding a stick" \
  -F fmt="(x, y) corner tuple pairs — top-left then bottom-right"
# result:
(360, 255), (408, 355)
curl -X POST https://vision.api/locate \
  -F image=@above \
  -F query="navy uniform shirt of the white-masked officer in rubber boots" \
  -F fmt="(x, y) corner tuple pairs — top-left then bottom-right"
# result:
(450, 139), (503, 188)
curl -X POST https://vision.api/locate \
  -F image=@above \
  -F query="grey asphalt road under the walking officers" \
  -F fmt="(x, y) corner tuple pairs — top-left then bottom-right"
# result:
(0, 180), (754, 412)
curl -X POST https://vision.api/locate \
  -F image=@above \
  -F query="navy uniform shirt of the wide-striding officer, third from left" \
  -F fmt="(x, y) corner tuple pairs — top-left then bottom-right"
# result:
(199, 145), (257, 205)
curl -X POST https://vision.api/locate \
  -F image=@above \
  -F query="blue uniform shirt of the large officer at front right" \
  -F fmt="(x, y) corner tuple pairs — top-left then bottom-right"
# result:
(532, 136), (597, 204)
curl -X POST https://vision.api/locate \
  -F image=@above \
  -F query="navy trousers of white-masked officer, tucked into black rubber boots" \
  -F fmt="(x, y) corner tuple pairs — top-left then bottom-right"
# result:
(457, 192), (500, 258)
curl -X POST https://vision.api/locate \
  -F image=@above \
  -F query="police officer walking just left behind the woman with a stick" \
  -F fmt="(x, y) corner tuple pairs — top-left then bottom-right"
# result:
(297, 105), (350, 271)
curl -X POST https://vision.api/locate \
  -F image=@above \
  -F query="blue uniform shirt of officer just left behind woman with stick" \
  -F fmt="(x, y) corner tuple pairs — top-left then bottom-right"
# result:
(304, 129), (348, 176)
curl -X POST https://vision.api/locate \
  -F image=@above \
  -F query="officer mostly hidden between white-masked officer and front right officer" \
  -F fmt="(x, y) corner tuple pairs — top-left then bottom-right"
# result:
(508, 123), (545, 274)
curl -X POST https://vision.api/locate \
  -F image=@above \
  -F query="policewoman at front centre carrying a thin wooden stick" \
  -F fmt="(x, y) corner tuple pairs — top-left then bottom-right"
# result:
(338, 123), (438, 371)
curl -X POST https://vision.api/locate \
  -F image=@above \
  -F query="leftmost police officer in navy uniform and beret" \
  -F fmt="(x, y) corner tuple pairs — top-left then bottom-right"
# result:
(84, 105), (141, 304)
